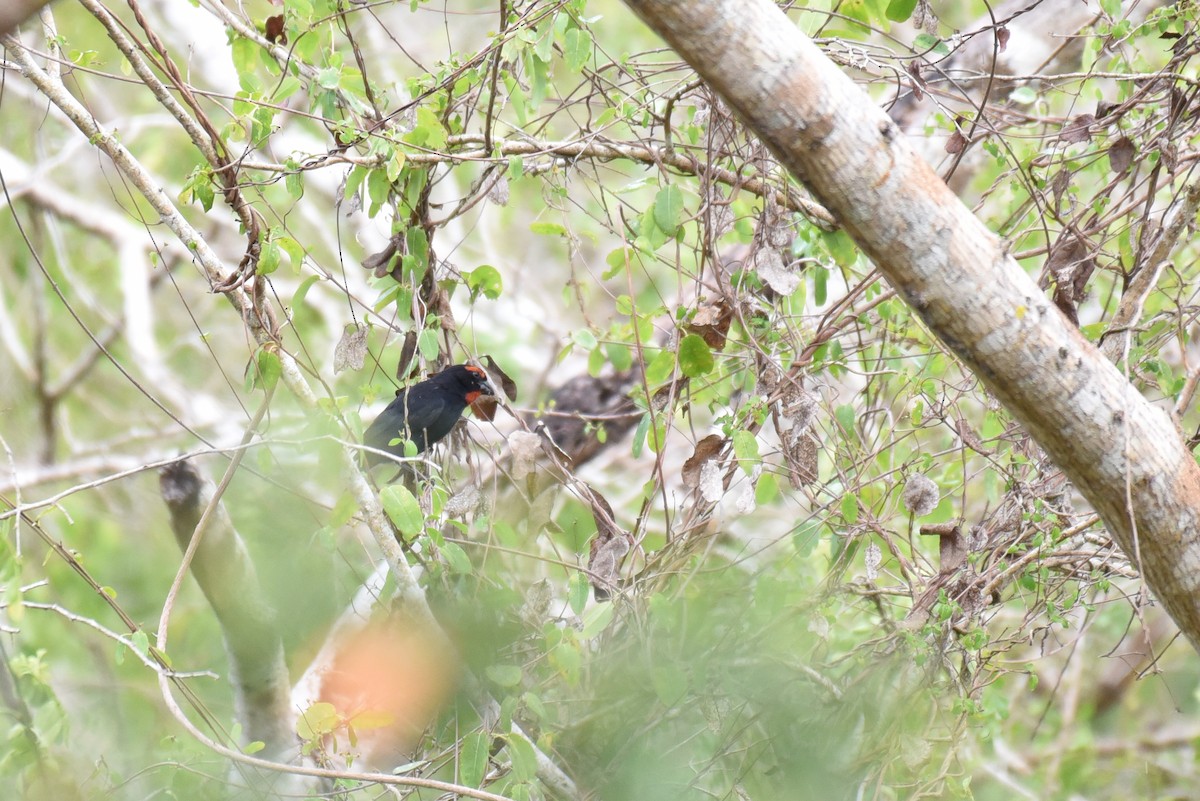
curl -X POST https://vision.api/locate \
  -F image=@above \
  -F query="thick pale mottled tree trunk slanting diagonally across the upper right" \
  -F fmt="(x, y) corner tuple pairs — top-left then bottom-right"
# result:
(626, 0), (1200, 649)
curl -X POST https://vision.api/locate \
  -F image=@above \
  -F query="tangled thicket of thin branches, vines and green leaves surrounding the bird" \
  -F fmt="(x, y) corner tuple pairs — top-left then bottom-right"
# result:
(0, 0), (1200, 799)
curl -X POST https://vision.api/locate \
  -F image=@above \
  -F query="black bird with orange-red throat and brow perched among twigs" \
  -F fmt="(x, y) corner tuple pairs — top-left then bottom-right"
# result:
(362, 365), (496, 468)
